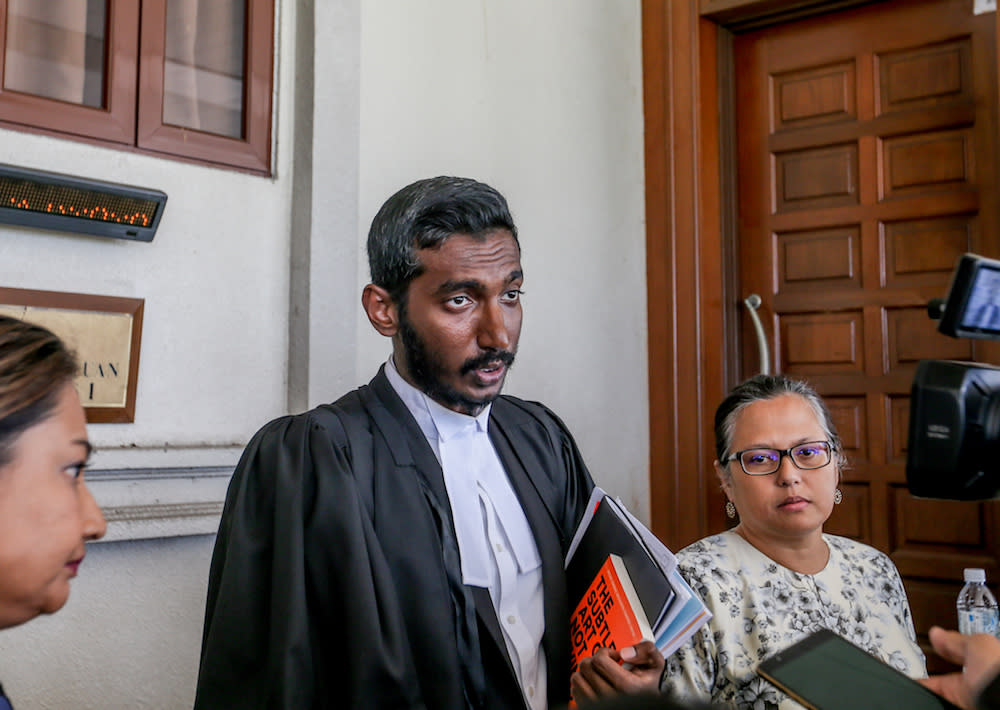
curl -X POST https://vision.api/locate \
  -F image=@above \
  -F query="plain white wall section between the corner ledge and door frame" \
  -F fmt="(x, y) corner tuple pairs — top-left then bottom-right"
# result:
(358, 0), (649, 517)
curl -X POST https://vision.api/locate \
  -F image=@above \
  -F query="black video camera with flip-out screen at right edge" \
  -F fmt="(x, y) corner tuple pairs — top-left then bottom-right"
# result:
(906, 254), (1000, 500)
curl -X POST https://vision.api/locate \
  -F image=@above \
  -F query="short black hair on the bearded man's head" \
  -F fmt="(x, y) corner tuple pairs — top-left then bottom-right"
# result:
(368, 176), (520, 303)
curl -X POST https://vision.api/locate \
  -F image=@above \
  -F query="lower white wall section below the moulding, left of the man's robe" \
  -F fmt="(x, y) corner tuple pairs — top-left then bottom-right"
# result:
(0, 536), (212, 710)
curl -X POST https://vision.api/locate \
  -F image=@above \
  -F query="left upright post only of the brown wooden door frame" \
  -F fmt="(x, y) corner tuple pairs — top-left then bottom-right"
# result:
(642, 0), (725, 549)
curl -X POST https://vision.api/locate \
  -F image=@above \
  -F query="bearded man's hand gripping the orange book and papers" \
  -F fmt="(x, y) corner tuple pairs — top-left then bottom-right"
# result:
(570, 641), (664, 704)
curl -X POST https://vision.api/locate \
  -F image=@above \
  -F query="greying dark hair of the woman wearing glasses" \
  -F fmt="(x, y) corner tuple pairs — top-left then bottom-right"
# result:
(715, 375), (847, 471)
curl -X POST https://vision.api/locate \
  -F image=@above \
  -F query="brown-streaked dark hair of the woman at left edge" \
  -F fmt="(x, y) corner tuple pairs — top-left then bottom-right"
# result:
(0, 316), (77, 466)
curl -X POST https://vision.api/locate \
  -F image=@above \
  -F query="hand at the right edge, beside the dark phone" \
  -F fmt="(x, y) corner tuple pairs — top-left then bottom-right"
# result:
(920, 626), (1000, 710)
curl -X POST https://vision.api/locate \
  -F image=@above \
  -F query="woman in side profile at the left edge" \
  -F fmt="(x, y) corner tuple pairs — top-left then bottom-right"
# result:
(0, 316), (105, 710)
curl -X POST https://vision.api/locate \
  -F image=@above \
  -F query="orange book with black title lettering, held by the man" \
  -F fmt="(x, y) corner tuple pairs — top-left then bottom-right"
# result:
(569, 554), (654, 673)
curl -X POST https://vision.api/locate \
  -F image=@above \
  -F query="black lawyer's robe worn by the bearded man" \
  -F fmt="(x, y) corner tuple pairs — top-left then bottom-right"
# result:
(195, 370), (593, 710)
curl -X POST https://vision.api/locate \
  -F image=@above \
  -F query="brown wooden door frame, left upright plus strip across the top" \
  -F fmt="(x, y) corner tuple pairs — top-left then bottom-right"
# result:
(642, 0), (1000, 549)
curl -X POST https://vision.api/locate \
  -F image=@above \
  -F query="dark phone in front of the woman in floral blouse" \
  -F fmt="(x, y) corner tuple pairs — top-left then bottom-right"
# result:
(757, 629), (957, 710)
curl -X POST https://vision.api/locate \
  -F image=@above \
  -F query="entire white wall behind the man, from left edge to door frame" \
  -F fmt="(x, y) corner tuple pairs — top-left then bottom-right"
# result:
(0, 0), (649, 709)
